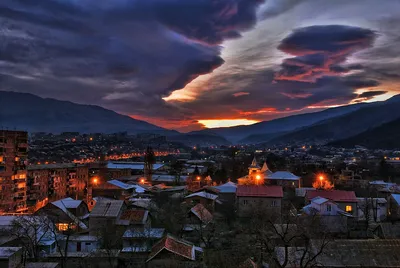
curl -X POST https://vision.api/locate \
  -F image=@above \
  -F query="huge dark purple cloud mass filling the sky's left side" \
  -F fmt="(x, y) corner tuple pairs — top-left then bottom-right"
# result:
(0, 0), (263, 117)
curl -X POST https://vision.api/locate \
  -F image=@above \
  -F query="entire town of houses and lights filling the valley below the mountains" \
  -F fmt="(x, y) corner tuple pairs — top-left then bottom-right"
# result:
(0, 130), (400, 268)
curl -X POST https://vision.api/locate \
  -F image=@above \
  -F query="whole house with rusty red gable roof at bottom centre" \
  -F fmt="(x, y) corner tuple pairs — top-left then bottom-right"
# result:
(146, 234), (203, 268)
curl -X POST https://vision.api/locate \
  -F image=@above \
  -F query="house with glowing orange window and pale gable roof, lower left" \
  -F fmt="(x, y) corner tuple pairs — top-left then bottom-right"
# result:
(35, 197), (89, 231)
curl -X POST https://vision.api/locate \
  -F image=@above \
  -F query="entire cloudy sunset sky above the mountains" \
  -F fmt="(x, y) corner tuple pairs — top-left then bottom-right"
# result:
(0, 0), (400, 131)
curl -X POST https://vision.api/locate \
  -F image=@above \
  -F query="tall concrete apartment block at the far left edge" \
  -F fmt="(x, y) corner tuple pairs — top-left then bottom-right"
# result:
(0, 130), (28, 213)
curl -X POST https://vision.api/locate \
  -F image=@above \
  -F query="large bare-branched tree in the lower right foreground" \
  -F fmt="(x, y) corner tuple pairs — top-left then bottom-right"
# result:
(250, 207), (331, 268)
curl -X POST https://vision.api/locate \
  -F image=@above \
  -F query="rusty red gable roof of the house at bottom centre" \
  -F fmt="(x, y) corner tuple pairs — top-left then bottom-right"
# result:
(147, 235), (195, 261)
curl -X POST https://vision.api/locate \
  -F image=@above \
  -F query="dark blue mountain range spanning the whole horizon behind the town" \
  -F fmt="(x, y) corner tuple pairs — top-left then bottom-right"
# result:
(0, 91), (400, 147)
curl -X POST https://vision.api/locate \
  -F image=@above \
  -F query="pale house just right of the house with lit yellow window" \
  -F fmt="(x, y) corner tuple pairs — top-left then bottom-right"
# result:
(357, 197), (387, 222)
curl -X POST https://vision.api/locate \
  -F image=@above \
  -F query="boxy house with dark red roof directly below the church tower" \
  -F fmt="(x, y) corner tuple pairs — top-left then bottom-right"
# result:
(236, 185), (283, 217)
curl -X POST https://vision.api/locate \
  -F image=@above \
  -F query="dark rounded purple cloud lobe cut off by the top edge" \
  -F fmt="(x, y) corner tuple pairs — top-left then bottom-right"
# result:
(154, 0), (264, 44)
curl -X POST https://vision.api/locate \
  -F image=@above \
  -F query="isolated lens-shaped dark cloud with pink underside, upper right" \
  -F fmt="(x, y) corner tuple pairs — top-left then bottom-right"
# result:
(276, 25), (376, 82)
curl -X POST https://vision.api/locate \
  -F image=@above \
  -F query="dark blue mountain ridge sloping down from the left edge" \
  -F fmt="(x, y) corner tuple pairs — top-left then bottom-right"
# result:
(0, 91), (178, 134)
